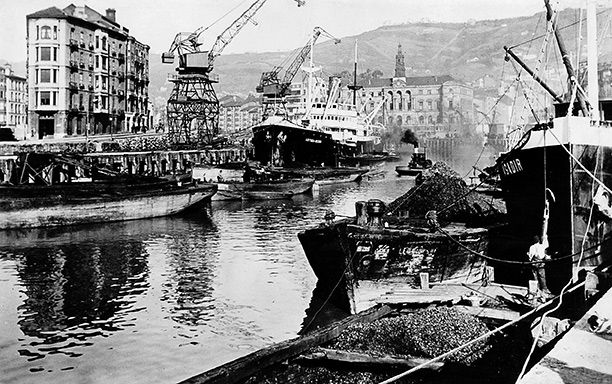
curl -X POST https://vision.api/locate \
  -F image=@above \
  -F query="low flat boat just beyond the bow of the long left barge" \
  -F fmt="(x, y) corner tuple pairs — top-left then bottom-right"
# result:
(213, 178), (315, 201)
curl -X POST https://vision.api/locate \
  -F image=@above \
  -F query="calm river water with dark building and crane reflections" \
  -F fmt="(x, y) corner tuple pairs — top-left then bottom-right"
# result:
(0, 164), (413, 384)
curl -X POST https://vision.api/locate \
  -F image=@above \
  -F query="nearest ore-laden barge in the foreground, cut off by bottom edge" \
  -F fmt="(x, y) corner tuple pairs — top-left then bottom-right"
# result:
(175, 283), (596, 384)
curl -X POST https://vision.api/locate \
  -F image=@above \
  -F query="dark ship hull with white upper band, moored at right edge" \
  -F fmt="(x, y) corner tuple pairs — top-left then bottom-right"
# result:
(497, 117), (612, 292)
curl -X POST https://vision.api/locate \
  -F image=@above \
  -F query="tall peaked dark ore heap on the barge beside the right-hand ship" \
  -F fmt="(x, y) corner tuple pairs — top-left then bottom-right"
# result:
(387, 162), (505, 223)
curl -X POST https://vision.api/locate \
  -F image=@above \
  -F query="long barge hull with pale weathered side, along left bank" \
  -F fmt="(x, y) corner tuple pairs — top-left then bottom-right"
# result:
(0, 183), (216, 229)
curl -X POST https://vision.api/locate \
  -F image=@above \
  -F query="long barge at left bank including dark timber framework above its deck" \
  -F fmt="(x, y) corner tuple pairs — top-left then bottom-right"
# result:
(0, 153), (217, 229)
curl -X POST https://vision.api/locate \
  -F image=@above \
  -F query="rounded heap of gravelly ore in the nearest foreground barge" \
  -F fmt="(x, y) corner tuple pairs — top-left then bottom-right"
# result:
(330, 307), (488, 365)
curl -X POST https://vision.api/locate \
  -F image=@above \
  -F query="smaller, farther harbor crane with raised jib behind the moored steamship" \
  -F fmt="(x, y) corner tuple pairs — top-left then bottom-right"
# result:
(255, 27), (340, 119)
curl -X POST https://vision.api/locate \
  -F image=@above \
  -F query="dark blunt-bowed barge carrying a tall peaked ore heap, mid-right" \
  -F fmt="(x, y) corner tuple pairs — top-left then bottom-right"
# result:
(298, 163), (503, 306)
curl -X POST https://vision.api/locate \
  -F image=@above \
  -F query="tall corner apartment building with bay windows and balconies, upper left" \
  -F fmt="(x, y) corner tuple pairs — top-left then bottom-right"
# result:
(26, 5), (150, 139)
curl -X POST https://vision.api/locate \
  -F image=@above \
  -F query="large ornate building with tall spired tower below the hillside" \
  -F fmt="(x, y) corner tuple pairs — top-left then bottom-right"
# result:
(340, 45), (474, 140)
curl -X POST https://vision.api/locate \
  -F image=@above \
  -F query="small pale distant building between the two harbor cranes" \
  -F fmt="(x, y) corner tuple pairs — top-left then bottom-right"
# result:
(219, 95), (262, 134)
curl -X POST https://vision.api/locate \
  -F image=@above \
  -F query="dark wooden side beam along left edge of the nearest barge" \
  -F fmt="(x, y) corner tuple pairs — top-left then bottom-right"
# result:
(181, 305), (393, 384)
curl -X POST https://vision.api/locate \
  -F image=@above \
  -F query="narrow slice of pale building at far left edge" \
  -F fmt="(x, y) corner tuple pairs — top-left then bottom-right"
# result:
(0, 65), (28, 140)
